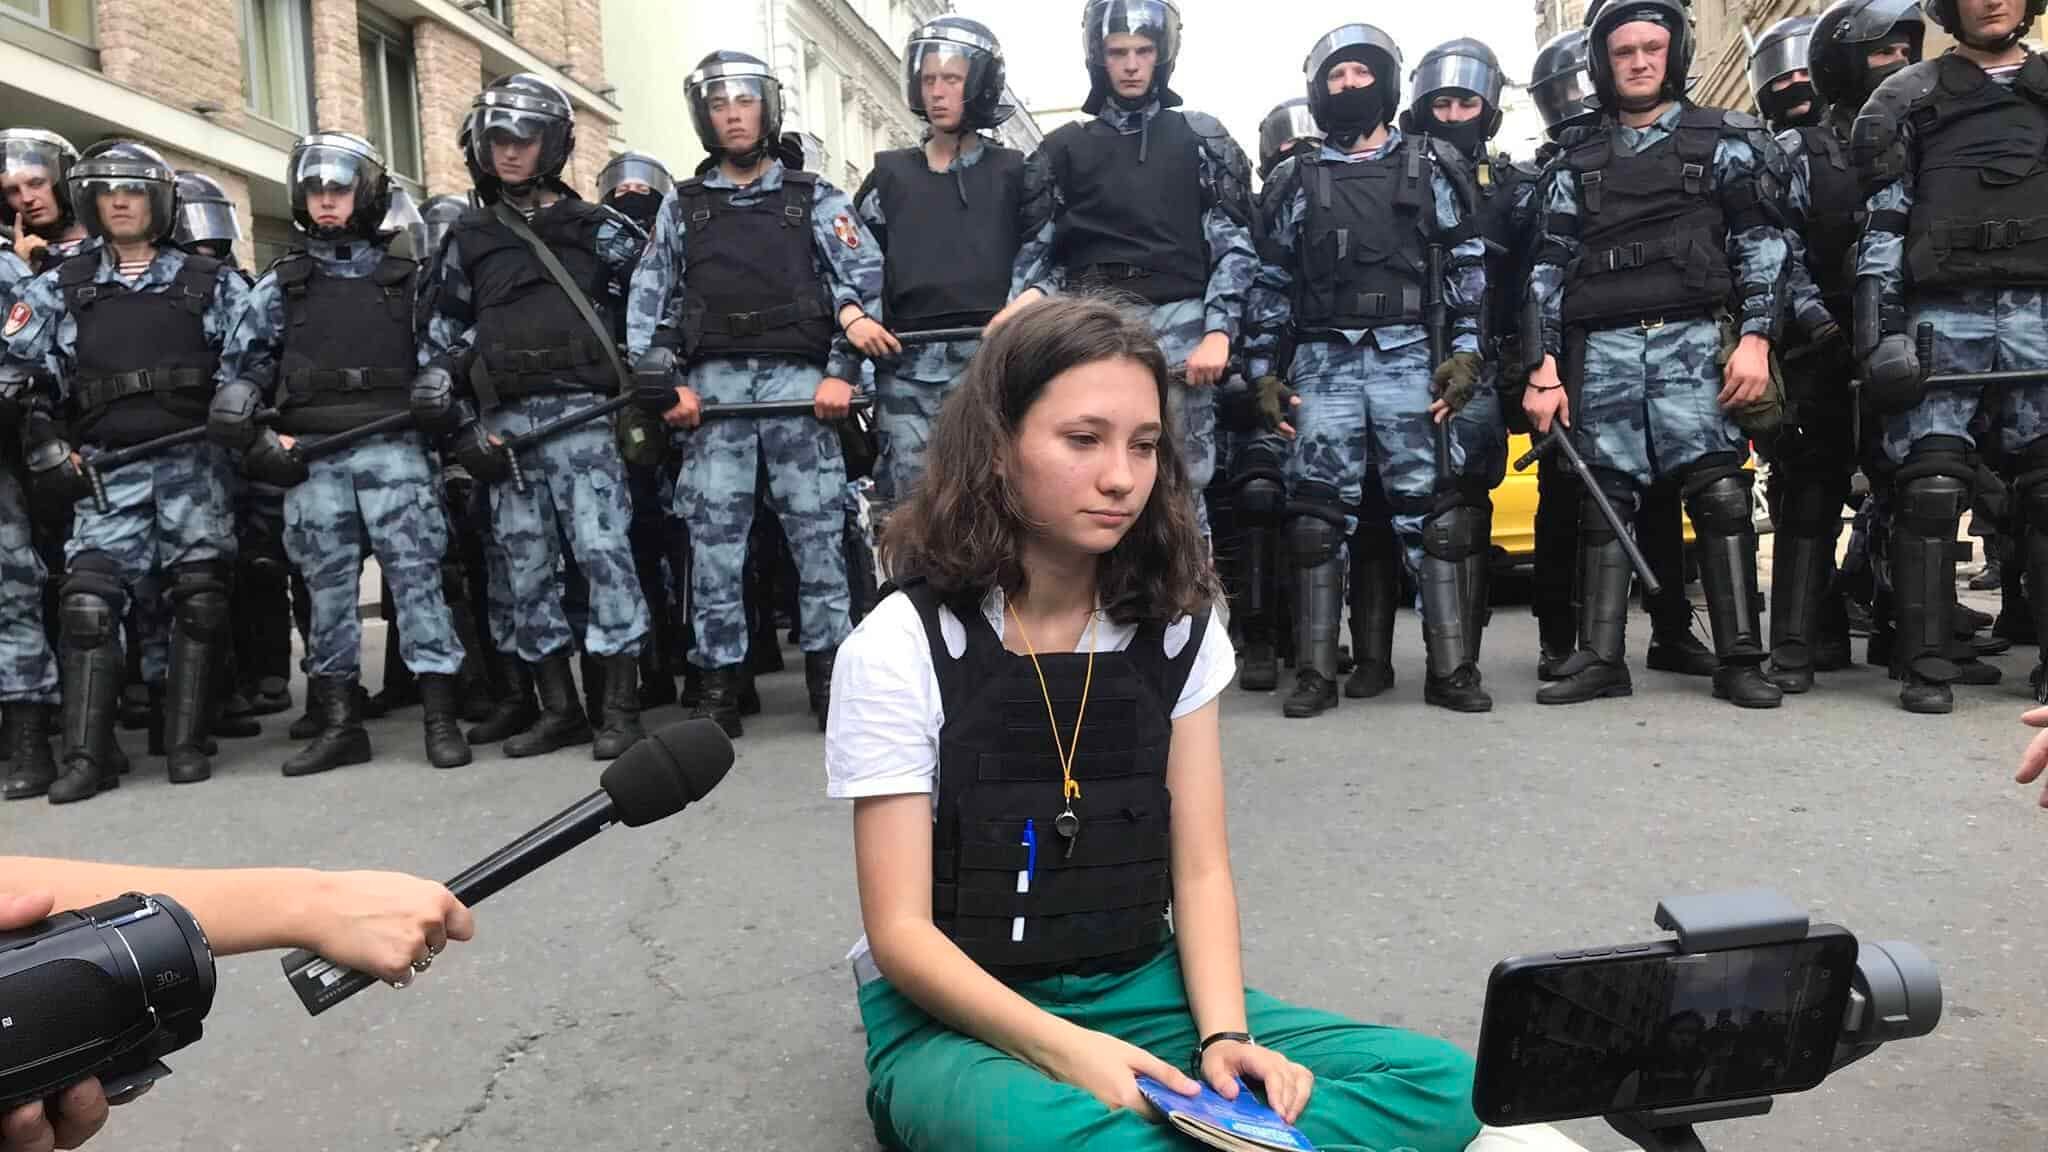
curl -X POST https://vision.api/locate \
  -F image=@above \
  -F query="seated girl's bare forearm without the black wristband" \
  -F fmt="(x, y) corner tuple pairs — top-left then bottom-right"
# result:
(868, 920), (1079, 1070)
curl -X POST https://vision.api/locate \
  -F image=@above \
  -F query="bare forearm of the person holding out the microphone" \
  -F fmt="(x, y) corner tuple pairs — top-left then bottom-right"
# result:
(0, 857), (326, 955)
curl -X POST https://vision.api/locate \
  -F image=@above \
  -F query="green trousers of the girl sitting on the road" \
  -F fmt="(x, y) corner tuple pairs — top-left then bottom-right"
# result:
(860, 945), (1479, 1152)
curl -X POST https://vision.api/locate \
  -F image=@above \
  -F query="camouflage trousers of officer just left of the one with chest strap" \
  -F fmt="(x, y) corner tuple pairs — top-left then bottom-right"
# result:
(285, 433), (463, 681)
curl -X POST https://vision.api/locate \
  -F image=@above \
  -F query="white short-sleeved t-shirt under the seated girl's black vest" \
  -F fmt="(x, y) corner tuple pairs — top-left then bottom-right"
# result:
(825, 590), (1237, 959)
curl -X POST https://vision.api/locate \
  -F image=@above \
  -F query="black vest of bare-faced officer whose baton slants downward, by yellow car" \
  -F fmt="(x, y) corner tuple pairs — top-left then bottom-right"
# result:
(1565, 107), (1735, 324)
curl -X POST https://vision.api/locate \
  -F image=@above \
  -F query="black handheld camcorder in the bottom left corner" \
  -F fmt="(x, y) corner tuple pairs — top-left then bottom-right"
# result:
(0, 892), (213, 1111)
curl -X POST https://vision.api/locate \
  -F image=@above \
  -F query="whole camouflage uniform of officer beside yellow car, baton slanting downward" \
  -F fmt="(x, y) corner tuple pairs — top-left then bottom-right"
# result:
(1530, 102), (1788, 492)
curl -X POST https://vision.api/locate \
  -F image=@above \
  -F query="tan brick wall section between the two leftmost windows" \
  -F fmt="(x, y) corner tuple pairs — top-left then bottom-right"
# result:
(94, 0), (246, 125)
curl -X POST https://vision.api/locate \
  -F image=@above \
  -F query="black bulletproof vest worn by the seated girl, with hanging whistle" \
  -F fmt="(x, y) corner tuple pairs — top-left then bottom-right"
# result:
(903, 580), (1208, 982)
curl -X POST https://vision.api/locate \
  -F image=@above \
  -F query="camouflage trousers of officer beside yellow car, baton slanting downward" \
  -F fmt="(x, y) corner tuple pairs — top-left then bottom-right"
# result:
(1571, 320), (1749, 492)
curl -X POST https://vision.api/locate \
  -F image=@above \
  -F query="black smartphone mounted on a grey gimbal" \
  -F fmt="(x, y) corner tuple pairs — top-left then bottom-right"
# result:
(1473, 890), (1942, 1152)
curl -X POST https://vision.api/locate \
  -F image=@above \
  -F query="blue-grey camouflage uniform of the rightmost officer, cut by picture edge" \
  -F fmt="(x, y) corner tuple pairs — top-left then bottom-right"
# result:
(1855, 91), (2048, 463)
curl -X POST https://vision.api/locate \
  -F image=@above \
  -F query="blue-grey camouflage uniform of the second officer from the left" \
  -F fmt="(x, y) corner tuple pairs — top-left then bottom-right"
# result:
(6, 244), (248, 683)
